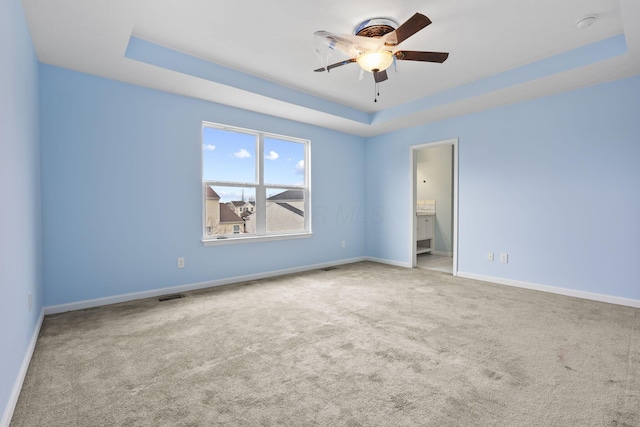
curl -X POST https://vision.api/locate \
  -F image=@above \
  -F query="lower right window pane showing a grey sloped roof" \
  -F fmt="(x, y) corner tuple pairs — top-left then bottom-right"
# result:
(266, 188), (304, 233)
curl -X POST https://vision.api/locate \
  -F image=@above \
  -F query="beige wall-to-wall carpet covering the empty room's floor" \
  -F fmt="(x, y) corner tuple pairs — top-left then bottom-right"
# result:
(11, 262), (640, 427)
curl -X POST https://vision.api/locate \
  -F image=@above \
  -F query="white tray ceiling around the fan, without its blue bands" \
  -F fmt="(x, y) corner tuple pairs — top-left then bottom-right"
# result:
(22, 0), (640, 136)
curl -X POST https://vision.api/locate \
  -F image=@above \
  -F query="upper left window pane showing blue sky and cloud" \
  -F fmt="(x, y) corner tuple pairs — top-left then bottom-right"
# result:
(202, 127), (257, 183)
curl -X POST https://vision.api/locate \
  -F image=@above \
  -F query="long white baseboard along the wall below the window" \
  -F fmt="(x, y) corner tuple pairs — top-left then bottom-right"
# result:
(43, 257), (365, 314)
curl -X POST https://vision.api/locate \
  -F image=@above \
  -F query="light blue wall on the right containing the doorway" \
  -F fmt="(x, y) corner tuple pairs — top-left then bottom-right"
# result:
(366, 76), (640, 299)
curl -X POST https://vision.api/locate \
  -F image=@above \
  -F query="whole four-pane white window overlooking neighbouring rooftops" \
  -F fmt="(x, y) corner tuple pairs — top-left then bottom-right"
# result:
(202, 122), (311, 245)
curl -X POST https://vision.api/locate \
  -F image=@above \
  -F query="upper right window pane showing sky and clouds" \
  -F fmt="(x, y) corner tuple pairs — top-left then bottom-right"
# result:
(264, 137), (305, 186)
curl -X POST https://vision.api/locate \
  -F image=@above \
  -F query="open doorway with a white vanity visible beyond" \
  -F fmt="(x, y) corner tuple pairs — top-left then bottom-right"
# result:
(410, 138), (458, 276)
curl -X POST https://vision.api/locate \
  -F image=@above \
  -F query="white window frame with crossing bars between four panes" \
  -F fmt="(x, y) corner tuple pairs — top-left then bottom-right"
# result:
(200, 121), (313, 246)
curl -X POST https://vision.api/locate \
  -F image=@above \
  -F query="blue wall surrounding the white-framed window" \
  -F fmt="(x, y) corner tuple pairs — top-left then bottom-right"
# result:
(40, 65), (365, 306)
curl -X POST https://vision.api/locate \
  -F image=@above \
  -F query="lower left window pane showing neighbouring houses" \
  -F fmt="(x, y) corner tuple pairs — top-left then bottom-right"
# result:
(205, 185), (256, 236)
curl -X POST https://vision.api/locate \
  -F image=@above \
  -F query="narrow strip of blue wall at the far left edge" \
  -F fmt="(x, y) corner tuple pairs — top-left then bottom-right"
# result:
(0, 0), (42, 418)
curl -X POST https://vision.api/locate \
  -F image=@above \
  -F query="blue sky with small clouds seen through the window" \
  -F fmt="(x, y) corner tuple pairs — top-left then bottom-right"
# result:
(202, 127), (304, 202)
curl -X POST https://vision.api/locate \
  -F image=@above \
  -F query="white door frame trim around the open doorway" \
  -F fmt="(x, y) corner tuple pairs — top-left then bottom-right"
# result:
(409, 138), (458, 276)
